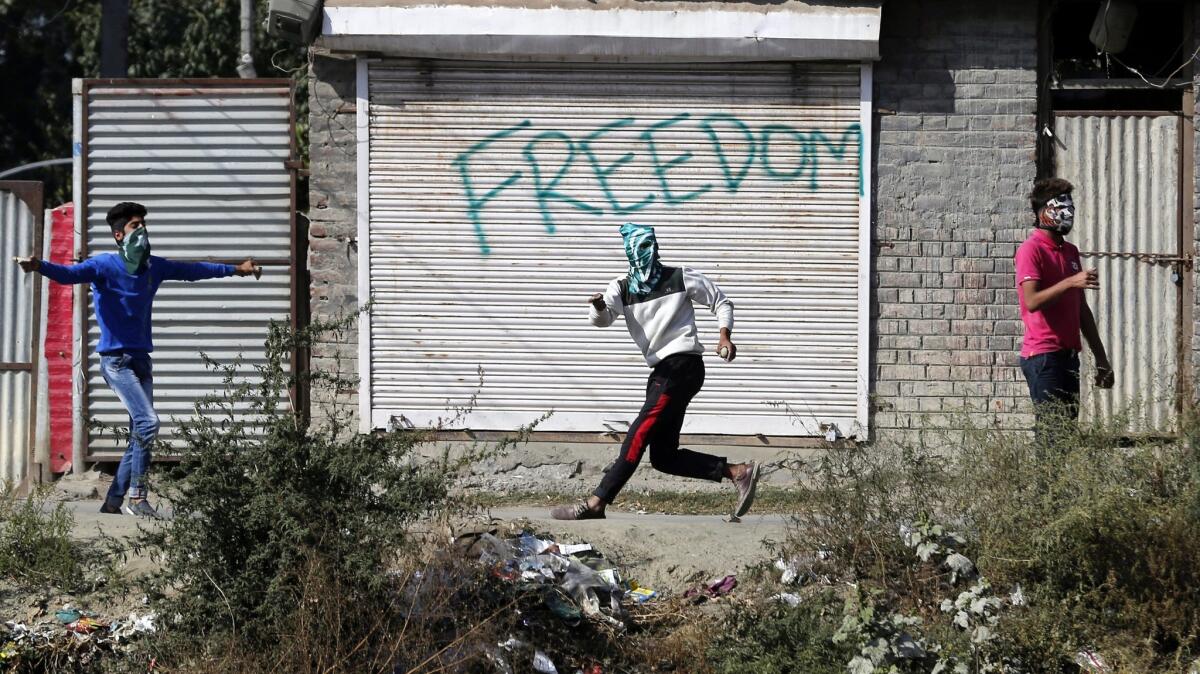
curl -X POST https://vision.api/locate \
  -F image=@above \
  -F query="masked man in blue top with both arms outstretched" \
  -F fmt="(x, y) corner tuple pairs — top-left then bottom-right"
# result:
(18, 201), (262, 517)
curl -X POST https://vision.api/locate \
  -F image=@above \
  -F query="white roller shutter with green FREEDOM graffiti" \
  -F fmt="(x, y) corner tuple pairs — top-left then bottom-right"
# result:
(368, 61), (866, 435)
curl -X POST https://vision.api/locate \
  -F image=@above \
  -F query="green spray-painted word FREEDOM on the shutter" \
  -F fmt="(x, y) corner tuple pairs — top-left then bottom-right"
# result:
(454, 113), (863, 254)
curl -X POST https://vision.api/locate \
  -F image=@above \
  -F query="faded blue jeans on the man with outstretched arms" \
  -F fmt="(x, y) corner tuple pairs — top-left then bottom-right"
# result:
(100, 354), (158, 506)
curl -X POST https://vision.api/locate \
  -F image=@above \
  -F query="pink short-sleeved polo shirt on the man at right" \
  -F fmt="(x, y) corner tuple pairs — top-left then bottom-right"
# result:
(1015, 229), (1084, 359)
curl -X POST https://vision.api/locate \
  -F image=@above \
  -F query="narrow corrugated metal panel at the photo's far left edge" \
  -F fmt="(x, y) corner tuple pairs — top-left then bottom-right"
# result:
(0, 189), (37, 481)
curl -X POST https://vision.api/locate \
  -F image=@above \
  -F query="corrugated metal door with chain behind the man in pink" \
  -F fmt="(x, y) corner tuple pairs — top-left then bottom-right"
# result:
(1055, 116), (1181, 433)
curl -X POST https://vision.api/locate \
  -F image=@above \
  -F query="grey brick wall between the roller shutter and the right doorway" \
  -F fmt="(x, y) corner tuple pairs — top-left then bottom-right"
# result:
(871, 0), (1037, 438)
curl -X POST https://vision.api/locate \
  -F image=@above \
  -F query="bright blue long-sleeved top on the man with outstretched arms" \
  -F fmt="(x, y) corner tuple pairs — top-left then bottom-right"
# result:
(38, 253), (235, 354)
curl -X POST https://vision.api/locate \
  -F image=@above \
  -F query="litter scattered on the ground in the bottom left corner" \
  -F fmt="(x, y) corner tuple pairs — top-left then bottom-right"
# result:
(0, 604), (157, 669)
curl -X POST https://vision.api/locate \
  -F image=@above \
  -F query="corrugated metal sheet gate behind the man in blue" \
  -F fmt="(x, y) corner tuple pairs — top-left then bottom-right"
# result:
(85, 80), (292, 455)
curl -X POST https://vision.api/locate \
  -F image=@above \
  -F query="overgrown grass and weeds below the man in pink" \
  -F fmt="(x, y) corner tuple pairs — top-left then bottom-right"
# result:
(709, 400), (1200, 674)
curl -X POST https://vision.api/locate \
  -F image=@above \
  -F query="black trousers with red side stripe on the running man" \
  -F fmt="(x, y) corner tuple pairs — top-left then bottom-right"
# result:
(594, 354), (725, 504)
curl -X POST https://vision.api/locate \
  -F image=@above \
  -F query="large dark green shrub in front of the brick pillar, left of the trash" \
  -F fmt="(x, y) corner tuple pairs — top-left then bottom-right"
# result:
(143, 317), (454, 672)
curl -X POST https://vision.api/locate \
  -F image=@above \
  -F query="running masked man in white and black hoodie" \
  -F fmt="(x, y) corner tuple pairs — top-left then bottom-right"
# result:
(550, 223), (758, 519)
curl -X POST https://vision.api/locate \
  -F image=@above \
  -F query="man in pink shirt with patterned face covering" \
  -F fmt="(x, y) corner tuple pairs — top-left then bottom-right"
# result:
(1015, 177), (1112, 440)
